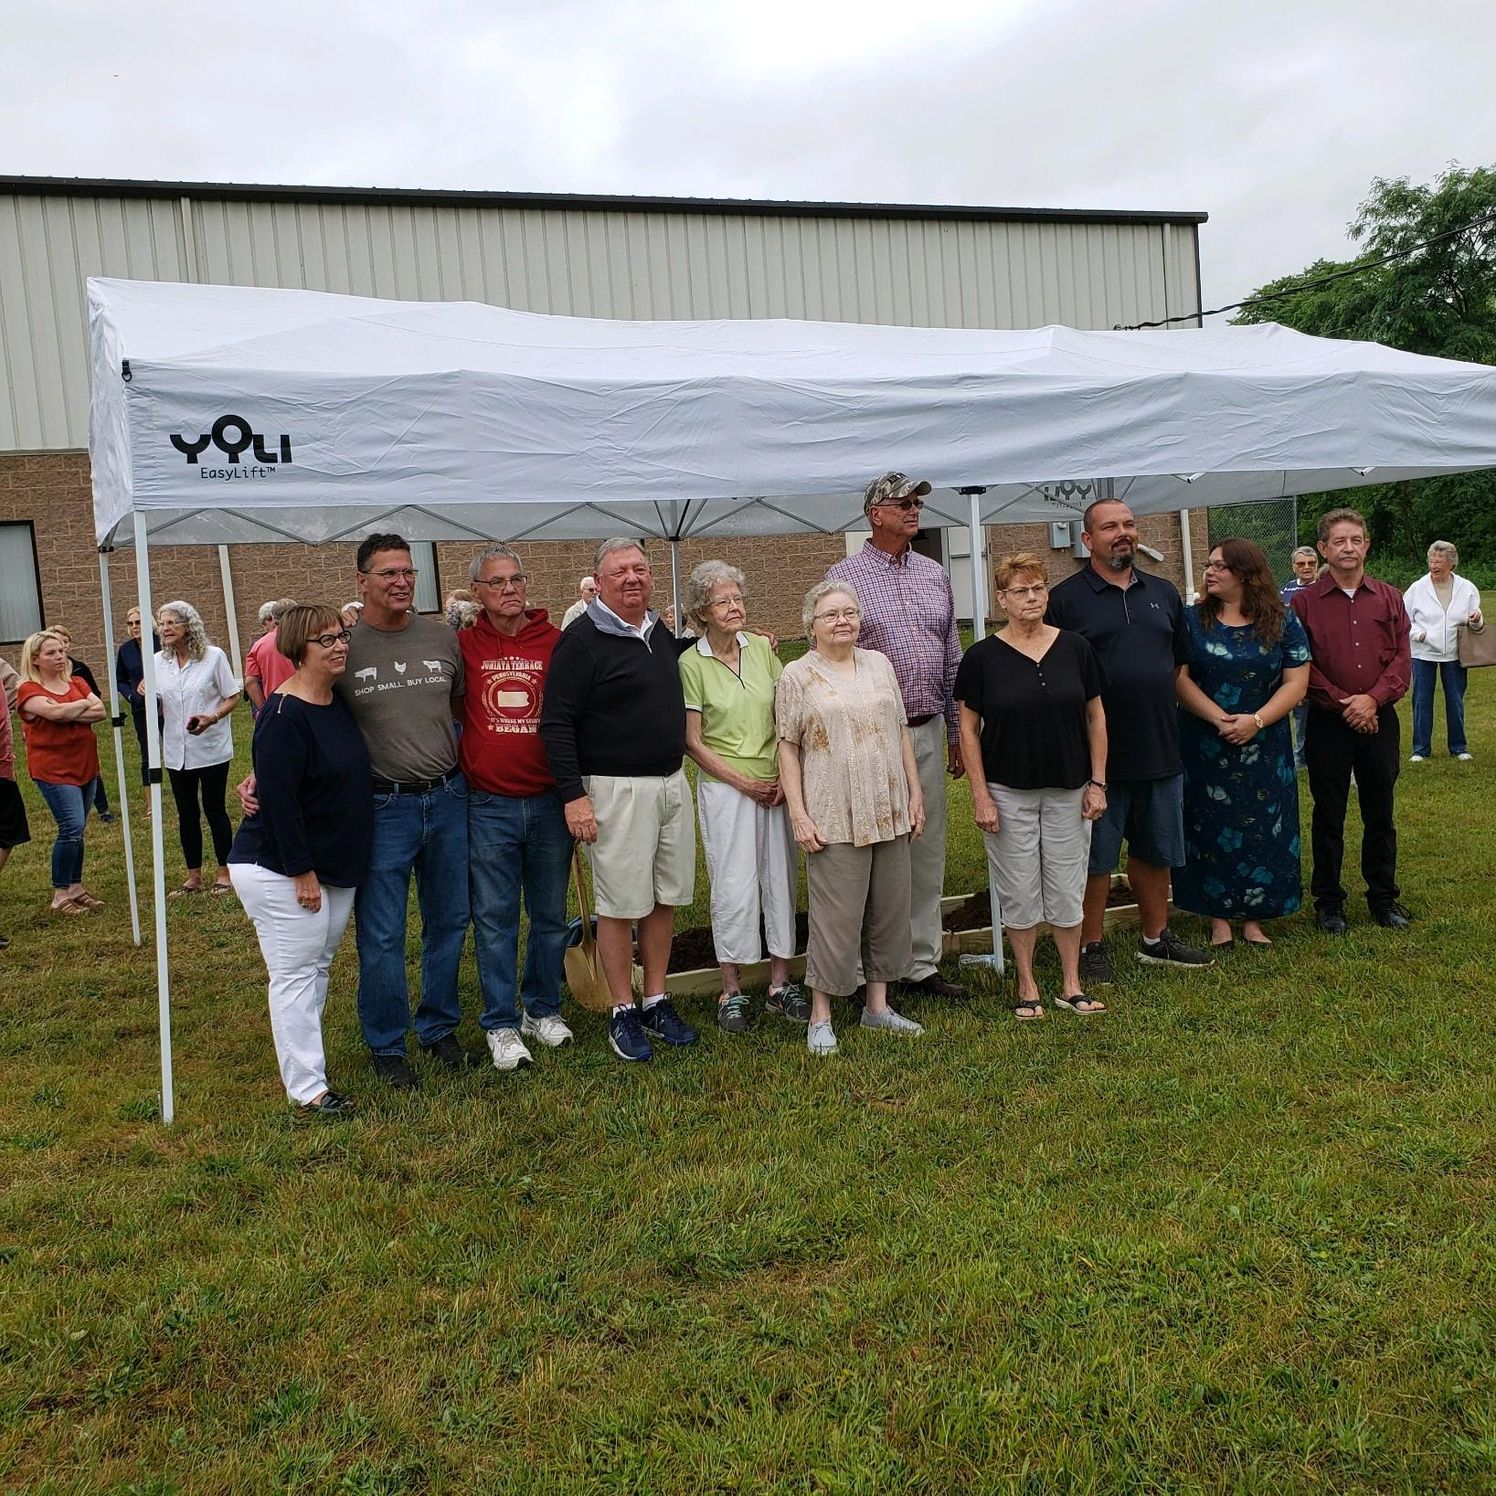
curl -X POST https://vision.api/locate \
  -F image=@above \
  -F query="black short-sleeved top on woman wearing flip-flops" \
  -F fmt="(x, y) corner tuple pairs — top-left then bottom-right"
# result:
(956, 630), (1107, 790)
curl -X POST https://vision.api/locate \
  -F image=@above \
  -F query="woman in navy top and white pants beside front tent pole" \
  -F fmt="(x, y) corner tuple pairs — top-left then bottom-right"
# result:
(229, 603), (374, 1119)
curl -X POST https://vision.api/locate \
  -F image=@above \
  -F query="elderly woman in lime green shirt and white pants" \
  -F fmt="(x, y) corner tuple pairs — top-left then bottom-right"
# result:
(681, 561), (811, 1034)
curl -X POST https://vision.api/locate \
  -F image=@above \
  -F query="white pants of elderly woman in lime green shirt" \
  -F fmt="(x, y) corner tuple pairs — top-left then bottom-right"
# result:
(696, 775), (799, 965)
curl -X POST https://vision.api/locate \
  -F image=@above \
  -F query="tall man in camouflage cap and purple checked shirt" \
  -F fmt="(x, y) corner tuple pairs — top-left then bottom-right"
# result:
(826, 473), (966, 998)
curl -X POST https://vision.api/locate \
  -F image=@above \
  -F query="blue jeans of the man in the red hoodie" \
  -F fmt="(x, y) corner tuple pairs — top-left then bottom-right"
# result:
(468, 790), (571, 1029)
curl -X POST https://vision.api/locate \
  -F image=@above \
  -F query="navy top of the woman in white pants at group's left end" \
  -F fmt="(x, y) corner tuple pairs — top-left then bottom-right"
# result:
(229, 691), (374, 889)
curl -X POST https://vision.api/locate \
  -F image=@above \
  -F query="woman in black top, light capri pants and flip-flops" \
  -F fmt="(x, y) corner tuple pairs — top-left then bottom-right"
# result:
(956, 551), (1107, 1020)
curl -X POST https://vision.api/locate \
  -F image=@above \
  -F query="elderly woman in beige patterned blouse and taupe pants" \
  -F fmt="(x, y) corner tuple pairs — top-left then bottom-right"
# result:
(773, 582), (925, 1056)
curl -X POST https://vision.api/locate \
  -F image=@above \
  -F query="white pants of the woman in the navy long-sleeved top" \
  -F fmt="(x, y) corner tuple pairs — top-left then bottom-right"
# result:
(229, 862), (353, 1103)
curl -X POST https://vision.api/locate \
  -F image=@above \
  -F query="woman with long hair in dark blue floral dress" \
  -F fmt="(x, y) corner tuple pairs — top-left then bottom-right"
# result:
(1174, 539), (1309, 951)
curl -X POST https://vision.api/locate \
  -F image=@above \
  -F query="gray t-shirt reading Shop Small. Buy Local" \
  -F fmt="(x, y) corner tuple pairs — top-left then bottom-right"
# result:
(335, 613), (464, 784)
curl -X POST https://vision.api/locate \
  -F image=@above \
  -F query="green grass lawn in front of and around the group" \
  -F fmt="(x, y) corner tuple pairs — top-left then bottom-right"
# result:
(0, 672), (1496, 1493)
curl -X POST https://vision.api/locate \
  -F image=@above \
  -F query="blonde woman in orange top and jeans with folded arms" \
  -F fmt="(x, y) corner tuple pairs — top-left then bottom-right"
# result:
(15, 628), (105, 914)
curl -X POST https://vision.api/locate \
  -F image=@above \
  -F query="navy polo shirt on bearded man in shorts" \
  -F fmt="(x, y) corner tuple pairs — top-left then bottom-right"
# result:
(1046, 565), (1189, 781)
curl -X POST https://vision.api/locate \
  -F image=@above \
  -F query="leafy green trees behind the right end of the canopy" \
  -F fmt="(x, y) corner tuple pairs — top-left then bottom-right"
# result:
(1234, 166), (1496, 582)
